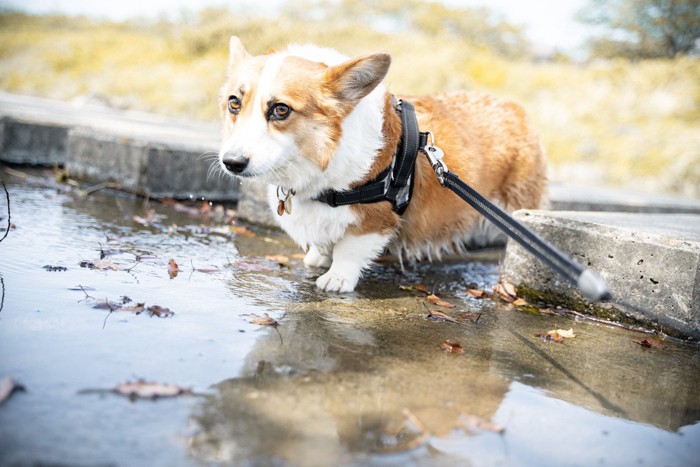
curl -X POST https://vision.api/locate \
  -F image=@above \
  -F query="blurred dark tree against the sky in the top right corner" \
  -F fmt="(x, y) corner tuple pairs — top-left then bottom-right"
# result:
(578, 0), (700, 59)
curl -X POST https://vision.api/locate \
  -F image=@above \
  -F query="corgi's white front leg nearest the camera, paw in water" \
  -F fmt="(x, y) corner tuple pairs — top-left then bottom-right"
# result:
(316, 233), (391, 292)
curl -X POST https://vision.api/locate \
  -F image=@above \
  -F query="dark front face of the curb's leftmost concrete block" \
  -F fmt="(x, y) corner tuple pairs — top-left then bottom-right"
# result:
(0, 117), (68, 166)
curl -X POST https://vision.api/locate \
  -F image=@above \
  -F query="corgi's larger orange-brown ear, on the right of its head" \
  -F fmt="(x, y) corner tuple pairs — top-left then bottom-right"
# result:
(324, 53), (391, 102)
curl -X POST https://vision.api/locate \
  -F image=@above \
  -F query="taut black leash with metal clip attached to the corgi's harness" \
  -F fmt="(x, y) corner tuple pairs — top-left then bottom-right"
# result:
(421, 133), (611, 302)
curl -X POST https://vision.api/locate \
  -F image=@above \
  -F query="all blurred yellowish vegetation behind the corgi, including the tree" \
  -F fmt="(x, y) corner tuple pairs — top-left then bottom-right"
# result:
(0, 0), (700, 197)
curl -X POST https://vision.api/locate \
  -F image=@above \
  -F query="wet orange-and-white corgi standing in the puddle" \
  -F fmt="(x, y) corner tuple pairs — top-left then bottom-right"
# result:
(219, 37), (546, 292)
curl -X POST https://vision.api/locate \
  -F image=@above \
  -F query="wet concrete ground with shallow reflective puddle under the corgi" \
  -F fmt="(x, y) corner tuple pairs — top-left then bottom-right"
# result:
(0, 169), (700, 466)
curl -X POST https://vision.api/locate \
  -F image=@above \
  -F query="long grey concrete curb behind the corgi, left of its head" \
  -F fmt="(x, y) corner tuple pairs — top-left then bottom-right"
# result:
(0, 92), (239, 201)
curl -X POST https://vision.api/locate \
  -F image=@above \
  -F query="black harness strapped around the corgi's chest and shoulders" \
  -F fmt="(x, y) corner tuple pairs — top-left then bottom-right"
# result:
(314, 96), (427, 215)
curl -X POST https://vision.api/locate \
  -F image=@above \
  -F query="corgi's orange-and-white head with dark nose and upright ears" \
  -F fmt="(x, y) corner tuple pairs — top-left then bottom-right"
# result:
(219, 37), (391, 187)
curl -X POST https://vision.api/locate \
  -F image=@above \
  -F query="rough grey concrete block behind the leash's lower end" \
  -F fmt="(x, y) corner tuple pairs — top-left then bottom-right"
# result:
(502, 210), (700, 338)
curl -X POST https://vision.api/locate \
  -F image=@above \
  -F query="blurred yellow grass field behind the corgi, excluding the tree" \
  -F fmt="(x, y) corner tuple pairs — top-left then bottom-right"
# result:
(0, 10), (700, 197)
